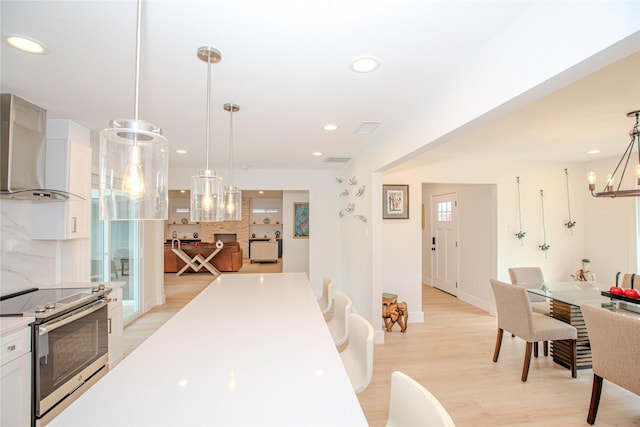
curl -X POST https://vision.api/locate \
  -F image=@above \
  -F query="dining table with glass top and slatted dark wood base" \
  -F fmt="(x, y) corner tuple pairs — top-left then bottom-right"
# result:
(526, 281), (640, 369)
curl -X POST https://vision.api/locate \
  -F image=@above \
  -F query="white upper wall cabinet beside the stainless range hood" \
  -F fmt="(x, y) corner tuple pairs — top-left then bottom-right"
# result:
(31, 119), (91, 240)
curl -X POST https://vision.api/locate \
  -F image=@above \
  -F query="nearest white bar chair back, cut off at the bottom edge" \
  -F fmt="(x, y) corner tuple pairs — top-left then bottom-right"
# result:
(387, 371), (455, 427)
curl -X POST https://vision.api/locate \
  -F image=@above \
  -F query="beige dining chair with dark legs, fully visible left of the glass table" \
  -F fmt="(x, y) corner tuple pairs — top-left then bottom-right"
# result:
(489, 279), (578, 382)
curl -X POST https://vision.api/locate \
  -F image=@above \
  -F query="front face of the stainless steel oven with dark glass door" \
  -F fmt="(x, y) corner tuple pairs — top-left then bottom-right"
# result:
(33, 299), (109, 418)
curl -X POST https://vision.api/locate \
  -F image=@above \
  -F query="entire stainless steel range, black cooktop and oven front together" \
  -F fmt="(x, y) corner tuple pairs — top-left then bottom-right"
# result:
(0, 284), (111, 426)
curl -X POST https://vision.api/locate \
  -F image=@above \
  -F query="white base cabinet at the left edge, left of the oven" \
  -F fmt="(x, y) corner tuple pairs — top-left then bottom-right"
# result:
(0, 327), (31, 427)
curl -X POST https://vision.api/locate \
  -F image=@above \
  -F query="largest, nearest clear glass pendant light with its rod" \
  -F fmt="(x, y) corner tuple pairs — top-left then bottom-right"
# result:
(99, 0), (169, 220)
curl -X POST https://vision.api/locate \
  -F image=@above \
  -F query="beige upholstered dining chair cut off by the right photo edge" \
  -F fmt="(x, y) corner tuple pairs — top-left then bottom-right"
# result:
(580, 305), (640, 424)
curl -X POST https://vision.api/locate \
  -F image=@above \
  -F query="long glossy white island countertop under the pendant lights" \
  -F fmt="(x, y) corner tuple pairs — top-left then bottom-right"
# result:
(49, 273), (367, 427)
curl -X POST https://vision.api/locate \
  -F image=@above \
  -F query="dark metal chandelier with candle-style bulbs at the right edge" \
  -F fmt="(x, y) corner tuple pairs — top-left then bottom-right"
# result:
(587, 110), (640, 198)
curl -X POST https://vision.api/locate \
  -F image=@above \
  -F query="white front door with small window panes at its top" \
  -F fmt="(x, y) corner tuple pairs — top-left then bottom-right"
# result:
(431, 193), (458, 296)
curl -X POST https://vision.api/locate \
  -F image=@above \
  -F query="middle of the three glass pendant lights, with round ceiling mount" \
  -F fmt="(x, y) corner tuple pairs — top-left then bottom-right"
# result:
(191, 46), (224, 222)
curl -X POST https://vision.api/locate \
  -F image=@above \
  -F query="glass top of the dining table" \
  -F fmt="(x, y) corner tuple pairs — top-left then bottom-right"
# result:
(527, 282), (640, 318)
